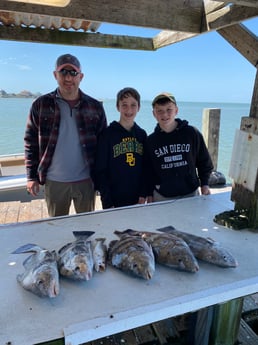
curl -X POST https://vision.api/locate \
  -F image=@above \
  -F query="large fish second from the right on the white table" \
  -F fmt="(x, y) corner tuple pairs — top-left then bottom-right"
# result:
(117, 229), (199, 273)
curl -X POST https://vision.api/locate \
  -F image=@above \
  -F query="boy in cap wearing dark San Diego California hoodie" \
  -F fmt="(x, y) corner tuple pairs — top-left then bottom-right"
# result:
(145, 92), (213, 202)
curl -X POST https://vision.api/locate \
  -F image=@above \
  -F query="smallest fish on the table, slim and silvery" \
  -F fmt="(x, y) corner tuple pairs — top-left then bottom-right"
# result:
(92, 238), (107, 272)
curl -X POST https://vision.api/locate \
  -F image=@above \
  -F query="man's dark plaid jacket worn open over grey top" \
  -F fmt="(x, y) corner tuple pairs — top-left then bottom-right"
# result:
(24, 89), (107, 184)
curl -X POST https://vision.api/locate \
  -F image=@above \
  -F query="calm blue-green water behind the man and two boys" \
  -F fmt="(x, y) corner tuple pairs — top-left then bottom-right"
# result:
(0, 98), (250, 183)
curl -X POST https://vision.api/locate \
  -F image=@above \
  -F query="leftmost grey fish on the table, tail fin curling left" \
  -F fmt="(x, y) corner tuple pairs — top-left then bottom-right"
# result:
(12, 243), (59, 298)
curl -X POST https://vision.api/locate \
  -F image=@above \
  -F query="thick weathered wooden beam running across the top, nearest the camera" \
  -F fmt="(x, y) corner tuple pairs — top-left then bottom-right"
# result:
(0, 0), (206, 33)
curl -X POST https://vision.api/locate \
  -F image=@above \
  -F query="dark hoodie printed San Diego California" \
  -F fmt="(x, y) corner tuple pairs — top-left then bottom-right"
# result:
(145, 119), (213, 198)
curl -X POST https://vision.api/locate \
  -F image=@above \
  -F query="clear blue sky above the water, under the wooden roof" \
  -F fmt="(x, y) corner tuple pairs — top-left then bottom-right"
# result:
(0, 18), (258, 103)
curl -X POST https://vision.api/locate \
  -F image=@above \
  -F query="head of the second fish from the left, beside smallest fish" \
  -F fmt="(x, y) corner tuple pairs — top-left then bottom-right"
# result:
(58, 253), (93, 280)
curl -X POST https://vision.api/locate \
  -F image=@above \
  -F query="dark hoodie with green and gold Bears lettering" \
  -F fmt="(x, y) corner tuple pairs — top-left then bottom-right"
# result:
(96, 121), (147, 209)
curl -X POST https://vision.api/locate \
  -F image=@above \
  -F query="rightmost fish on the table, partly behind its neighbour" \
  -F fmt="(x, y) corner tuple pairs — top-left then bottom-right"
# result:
(157, 226), (238, 268)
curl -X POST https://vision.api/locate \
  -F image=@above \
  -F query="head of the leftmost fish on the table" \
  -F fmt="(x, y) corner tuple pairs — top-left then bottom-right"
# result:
(20, 264), (60, 298)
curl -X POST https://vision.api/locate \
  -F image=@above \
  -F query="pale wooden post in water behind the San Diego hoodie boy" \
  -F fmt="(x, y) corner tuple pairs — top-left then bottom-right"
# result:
(202, 108), (220, 171)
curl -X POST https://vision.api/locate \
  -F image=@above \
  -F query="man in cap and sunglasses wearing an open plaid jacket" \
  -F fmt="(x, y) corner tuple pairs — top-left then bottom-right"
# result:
(24, 54), (107, 217)
